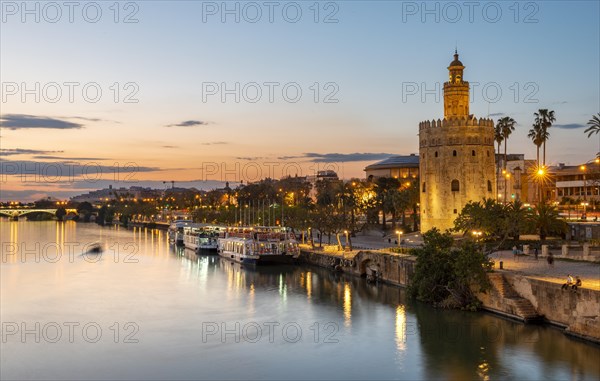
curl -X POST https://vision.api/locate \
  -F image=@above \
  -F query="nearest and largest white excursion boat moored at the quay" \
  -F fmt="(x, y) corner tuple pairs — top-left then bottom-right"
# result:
(218, 226), (300, 265)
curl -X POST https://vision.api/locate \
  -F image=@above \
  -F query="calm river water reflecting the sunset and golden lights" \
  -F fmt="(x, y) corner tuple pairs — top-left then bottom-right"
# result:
(0, 219), (600, 380)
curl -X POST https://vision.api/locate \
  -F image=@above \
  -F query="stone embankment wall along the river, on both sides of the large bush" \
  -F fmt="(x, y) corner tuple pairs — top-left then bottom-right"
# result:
(298, 250), (600, 343)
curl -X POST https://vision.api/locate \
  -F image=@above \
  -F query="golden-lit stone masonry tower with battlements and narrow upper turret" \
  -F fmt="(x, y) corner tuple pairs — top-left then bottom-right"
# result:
(419, 52), (496, 232)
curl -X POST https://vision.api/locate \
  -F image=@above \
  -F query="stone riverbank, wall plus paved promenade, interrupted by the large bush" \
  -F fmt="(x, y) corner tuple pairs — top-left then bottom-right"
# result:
(298, 248), (600, 344)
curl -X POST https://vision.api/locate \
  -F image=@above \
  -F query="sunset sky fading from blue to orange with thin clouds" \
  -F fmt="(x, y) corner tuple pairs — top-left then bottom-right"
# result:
(0, 1), (600, 201)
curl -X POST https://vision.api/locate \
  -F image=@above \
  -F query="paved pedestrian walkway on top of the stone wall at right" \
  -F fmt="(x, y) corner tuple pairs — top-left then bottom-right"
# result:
(491, 250), (600, 290)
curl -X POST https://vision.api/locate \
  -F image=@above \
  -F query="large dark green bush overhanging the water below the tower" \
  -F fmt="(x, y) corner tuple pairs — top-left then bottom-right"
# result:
(408, 228), (491, 309)
